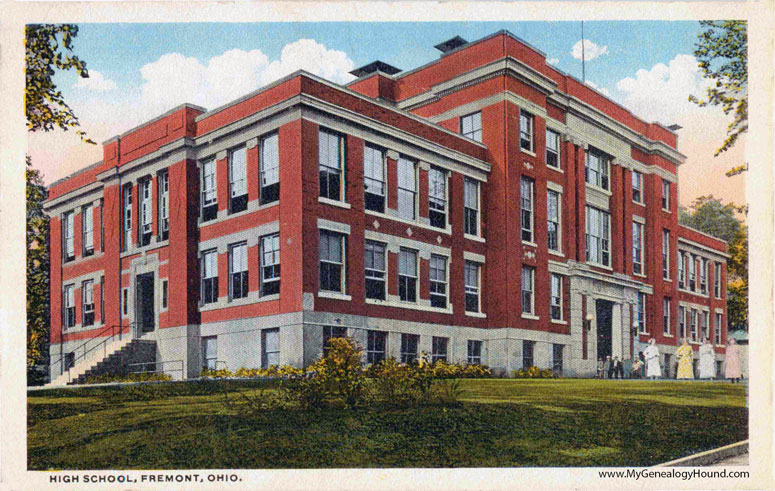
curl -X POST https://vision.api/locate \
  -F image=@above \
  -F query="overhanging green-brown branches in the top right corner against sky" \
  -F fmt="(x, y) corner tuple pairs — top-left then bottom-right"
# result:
(689, 20), (748, 176)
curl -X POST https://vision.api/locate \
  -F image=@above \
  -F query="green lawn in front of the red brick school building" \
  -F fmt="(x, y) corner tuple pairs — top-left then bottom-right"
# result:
(28, 379), (748, 470)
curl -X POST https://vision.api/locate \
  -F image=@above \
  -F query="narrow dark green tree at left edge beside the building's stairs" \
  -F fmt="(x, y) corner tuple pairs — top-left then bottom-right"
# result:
(25, 157), (50, 383)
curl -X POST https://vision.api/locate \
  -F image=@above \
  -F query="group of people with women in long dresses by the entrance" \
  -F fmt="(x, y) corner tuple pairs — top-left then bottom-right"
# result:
(597, 338), (742, 383)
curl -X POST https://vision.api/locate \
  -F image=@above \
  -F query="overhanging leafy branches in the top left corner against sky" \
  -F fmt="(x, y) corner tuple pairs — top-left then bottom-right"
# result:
(24, 24), (95, 145)
